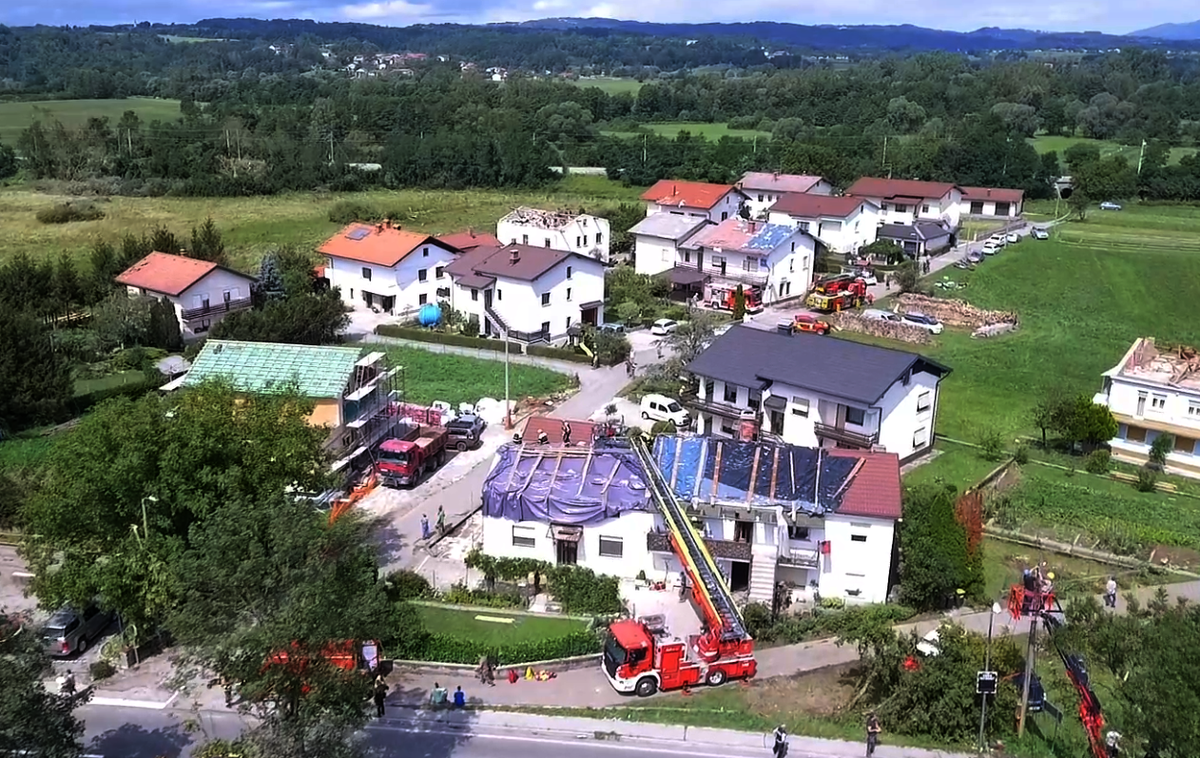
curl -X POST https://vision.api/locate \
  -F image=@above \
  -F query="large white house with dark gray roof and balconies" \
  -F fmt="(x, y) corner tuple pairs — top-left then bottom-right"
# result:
(684, 325), (950, 461)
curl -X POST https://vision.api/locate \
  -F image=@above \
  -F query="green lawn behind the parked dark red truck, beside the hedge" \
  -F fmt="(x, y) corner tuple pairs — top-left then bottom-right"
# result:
(374, 345), (572, 408)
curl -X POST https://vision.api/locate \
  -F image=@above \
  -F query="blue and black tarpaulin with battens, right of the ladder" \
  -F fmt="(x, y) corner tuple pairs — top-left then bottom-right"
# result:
(654, 435), (858, 515)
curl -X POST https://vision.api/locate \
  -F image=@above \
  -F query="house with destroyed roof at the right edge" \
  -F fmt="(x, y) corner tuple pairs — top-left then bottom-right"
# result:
(1092, 337), (1200, 477)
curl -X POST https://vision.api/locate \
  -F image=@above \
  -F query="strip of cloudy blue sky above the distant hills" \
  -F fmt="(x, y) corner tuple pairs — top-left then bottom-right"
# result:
(0, 0), (1200, 34)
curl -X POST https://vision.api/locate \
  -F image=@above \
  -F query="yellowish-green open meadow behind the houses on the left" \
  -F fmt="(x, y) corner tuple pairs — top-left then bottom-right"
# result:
(0, 175), (640, 267)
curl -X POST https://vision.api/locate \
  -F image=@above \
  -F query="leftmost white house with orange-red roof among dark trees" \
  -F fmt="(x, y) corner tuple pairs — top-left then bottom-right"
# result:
(116, 253), (254, 339)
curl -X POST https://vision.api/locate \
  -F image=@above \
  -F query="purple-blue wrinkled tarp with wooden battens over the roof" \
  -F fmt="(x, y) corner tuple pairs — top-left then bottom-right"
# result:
(484, 445), (653, 527)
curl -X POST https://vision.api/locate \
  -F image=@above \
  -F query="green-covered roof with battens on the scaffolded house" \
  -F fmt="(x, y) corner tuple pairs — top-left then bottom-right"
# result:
(184, 339), (362, 398)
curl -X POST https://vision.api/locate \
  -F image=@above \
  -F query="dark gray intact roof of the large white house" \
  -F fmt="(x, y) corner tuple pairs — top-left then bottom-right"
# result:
(688, 325), (950, 405)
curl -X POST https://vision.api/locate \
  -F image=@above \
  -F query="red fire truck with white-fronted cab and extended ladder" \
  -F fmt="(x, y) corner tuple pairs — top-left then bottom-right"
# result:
(601, 437), (757, 697)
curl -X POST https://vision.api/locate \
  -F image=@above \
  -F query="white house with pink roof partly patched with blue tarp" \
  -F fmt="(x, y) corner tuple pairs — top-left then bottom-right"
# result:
(673, 216), (816, 305)
